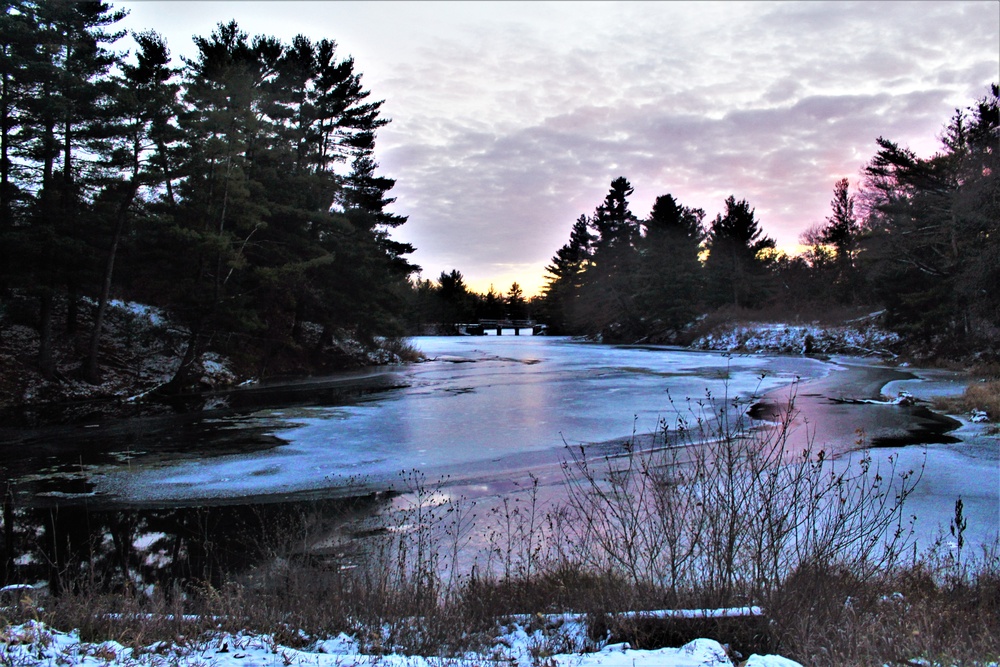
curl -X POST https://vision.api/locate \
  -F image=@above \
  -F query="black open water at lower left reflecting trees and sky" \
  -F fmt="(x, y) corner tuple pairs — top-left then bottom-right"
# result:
(2, 493), (392, 592)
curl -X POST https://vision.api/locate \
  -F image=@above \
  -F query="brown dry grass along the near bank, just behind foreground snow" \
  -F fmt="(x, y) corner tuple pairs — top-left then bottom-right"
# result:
(4, 544), (1000, 667)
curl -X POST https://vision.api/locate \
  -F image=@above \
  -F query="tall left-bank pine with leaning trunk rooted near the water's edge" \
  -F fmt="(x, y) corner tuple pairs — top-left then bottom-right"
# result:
(158, 22), (281, 391)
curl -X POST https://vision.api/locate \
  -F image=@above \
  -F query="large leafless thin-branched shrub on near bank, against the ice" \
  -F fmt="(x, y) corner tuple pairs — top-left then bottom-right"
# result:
(566, 384), (919, 606)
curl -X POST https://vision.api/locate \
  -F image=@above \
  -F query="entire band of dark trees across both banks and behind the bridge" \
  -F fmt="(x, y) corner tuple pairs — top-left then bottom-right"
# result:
(0, 0), (1000, 392)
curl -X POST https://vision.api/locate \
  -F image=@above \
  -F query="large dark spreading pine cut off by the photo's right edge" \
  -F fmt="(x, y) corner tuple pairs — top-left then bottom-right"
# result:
(859, 85), (1000, 354)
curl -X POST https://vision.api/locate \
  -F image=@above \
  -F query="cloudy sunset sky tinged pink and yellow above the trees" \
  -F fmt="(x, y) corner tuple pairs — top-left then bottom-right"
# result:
(117, 0), (1000, 295)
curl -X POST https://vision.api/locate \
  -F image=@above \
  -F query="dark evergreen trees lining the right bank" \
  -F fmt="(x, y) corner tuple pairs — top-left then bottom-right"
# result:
(536, 85), (1000, 354)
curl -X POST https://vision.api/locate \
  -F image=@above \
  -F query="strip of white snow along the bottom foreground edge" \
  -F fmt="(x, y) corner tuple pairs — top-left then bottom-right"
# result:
(0, 622), (801, 667)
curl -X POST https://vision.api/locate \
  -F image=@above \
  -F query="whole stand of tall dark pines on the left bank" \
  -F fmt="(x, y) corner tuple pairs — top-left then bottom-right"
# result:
(0, 0), (417, 391)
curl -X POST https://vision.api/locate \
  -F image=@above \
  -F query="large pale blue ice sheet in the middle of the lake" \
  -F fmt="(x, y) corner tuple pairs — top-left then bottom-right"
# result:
(96, 336), (828, 501)
